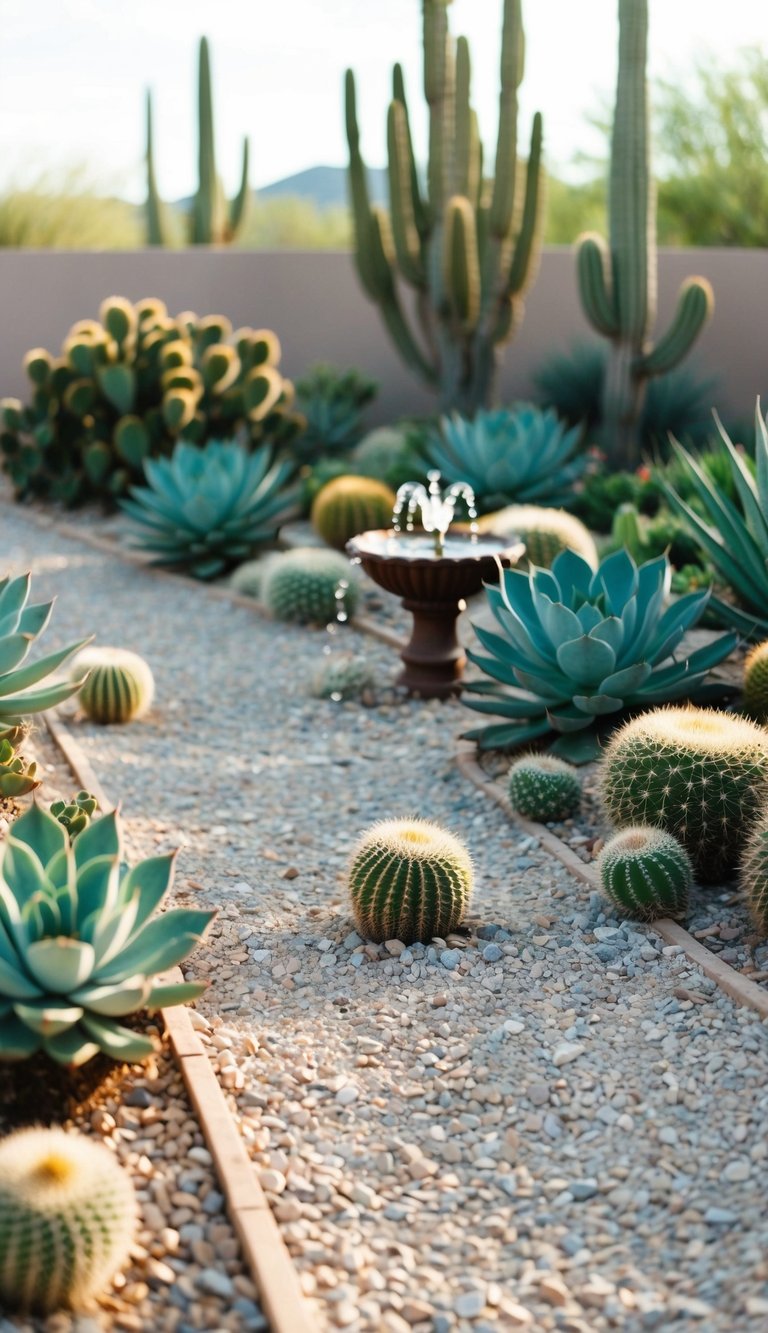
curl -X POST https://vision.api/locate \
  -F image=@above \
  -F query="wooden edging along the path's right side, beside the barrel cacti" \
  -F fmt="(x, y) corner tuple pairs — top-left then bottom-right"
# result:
(456, 741), (768, 1018)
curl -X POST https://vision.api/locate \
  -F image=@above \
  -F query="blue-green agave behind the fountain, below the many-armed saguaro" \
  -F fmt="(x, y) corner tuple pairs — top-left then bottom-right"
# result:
(427, 403), (587, 513)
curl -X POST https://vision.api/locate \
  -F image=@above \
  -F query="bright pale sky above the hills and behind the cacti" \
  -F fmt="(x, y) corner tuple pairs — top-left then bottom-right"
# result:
(0, 0), (768, 200)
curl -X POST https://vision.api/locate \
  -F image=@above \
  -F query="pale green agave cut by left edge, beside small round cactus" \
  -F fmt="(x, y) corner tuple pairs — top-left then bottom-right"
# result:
(0, 575), (89, 741)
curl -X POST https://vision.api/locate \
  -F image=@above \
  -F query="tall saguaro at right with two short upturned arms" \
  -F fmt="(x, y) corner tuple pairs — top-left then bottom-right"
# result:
(577, 0), (713, 467)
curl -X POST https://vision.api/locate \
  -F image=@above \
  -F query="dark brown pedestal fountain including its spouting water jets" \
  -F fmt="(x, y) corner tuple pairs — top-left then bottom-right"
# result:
(347, 472), (525, 698)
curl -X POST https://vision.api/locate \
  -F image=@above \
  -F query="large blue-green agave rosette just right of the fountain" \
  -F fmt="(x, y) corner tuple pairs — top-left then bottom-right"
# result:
(465, 551), (737, 762)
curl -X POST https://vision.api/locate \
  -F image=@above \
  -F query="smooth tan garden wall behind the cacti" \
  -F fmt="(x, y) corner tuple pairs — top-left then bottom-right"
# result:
(0, 249), (768, 420)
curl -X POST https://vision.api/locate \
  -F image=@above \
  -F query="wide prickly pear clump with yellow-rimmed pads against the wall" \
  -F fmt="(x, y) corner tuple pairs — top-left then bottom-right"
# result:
(0, 296), (303, 504)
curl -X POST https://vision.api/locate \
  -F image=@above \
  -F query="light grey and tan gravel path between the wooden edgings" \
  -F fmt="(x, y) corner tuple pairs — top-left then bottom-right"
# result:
(3, 509), (768, 1333)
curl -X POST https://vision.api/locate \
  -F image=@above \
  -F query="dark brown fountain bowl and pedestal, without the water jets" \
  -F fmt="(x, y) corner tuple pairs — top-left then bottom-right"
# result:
(347, 529), (525, 698)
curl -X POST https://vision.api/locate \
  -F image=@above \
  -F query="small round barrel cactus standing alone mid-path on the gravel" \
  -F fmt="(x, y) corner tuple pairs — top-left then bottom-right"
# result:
(348, 820), (473, 944)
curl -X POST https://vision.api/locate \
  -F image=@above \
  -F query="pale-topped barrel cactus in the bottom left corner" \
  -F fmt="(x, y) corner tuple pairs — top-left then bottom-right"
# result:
(0, 1129), (136, 1314)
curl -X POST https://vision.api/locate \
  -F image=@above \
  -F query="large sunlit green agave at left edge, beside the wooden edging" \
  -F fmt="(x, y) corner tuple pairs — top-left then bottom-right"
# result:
(0, 805), (213, 1065)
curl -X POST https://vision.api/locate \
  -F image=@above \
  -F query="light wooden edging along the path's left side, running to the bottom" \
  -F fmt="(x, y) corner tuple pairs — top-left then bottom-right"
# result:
(44, 713), (317, 1333)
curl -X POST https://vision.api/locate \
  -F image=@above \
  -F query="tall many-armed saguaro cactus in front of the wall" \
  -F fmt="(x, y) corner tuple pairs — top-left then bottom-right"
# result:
(347, 0), (543, 415)
